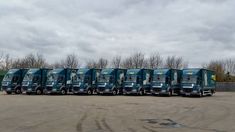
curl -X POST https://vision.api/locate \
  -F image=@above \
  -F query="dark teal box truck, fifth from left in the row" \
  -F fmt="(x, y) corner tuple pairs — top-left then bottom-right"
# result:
(97, 68), (126, 95)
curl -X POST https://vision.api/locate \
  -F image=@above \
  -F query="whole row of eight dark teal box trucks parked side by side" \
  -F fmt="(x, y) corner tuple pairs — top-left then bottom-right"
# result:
(2, 68), (216, 96)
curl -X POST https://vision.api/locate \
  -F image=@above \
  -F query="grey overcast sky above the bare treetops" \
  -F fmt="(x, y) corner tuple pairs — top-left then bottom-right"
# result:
(0, 0), (235, 66)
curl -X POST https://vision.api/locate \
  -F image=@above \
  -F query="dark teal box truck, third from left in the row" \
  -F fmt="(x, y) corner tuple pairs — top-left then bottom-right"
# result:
(44, 68), (77, 95)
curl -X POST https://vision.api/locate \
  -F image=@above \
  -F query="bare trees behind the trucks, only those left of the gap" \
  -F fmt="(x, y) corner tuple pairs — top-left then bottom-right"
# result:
(0, 52), (188, 70)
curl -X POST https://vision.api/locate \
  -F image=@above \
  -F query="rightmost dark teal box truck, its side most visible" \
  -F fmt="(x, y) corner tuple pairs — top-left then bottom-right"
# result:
(181, 68), (216, 97)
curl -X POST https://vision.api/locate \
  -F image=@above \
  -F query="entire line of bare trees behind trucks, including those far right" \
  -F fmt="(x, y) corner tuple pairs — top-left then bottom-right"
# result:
(0, 52), (235, 81)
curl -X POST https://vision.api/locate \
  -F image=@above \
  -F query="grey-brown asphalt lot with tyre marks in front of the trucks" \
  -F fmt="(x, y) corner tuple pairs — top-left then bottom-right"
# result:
(0, 92), (235, 132)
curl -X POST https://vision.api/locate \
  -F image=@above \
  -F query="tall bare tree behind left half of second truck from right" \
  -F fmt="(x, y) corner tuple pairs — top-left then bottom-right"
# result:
(148, 52), (163, 68)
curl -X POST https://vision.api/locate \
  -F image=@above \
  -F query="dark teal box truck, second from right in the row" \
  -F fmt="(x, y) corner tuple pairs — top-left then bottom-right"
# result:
(151, 68), (182, 96)
